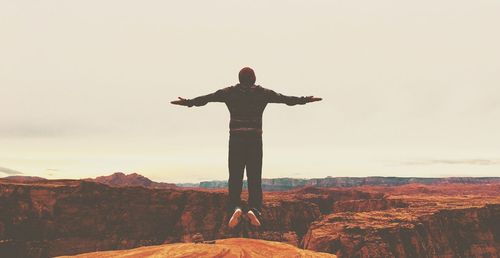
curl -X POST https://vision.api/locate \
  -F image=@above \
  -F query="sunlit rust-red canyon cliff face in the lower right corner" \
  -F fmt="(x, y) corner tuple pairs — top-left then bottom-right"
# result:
(303, 204), (500, 257)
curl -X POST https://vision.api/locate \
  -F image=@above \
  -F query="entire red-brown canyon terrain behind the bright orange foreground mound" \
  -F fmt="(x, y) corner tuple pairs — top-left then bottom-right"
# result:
(0, 180), (500, 257)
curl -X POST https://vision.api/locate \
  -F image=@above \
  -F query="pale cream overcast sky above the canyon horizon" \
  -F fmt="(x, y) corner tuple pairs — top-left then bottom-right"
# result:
(0, 0), (500, 183)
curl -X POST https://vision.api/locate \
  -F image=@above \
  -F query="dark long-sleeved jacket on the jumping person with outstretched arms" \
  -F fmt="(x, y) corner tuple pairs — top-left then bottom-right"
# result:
(189, 84), (307, 134)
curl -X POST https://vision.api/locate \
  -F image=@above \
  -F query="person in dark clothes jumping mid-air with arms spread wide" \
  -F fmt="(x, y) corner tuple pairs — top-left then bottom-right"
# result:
(171, 67), (321, 228)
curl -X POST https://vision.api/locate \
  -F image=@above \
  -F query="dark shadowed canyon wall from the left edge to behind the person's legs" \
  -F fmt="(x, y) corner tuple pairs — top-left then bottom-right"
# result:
(0, 180), (340, 257)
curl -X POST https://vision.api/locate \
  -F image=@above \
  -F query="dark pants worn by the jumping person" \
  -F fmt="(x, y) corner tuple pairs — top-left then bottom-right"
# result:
(228, 134), (262, 210)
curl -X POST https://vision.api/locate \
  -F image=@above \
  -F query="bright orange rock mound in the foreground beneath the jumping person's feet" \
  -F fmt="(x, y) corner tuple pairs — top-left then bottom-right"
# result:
(56, 238), (336, 258)
